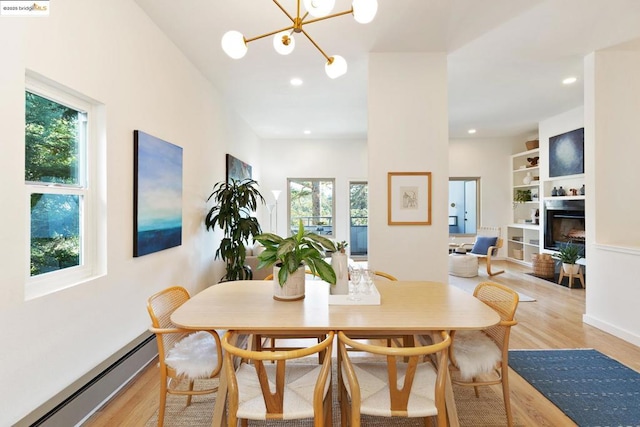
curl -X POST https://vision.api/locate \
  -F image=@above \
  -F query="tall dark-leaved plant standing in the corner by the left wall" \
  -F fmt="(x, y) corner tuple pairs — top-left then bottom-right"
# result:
(204, 179), (265, 281)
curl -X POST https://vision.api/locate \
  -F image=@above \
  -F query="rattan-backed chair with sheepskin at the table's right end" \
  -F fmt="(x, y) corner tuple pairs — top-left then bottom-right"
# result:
(449, 282), (519, 426)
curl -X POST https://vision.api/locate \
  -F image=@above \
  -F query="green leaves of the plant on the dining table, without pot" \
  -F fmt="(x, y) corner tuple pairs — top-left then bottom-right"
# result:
(254, 220), (336, 286)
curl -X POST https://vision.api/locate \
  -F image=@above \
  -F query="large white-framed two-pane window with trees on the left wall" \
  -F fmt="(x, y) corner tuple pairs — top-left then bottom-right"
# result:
(25, 74), (101, 294)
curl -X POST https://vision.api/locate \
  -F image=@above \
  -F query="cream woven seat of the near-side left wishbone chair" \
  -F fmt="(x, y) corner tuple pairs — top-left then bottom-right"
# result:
(236, 362), (330, 420)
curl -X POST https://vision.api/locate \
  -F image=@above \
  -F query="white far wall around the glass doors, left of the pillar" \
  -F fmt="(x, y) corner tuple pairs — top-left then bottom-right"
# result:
(255, 139), (367, 242)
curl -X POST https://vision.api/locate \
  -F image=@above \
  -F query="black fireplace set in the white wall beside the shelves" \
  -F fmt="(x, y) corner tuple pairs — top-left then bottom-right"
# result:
(544, 200), (585, 256)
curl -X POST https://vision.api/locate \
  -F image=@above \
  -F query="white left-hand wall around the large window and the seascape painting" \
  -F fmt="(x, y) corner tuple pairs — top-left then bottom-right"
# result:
(0, 0), (259, 425)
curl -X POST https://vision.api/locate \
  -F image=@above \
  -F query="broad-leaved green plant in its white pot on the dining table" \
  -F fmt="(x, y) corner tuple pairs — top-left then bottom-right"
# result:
(254, 220), (336, 301)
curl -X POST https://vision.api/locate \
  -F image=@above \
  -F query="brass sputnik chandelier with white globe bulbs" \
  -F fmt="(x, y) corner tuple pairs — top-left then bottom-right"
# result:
(222, 0), (378, 79)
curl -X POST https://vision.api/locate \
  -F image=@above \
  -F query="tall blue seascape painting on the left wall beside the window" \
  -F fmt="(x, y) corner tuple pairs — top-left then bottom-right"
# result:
(133, 130), (182, 257)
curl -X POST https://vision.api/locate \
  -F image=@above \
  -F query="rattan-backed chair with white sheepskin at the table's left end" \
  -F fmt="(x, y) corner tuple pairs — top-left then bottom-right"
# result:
(147, 286), (222, 426)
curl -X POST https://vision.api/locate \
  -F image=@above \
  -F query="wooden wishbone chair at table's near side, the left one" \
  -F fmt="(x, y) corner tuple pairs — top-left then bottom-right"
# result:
(222, 331), (334, 427)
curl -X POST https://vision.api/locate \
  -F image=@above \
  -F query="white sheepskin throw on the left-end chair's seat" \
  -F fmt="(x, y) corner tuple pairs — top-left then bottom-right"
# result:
(165, 331), (218, 379)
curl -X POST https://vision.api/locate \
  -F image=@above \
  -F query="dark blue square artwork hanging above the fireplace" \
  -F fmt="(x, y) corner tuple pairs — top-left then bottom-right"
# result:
(549, 128), (584, 178)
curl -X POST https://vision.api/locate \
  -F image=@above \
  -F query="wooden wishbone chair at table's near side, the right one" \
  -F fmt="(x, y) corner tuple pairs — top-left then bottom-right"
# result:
(338, 331), (451, 427)
